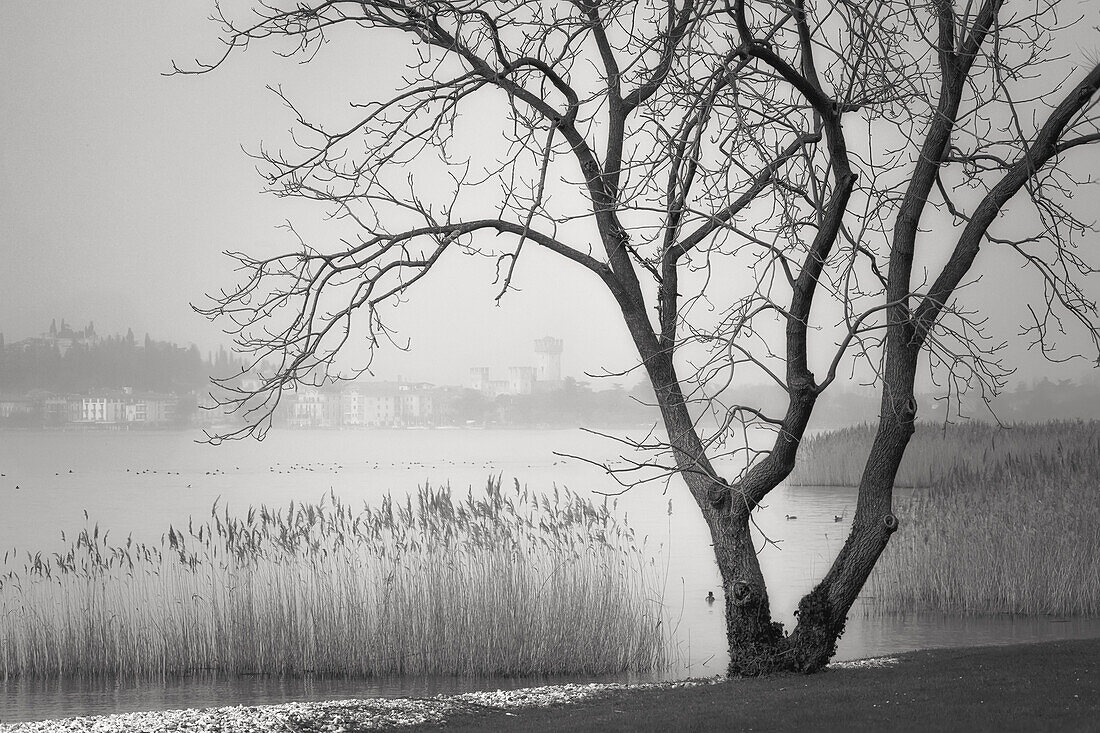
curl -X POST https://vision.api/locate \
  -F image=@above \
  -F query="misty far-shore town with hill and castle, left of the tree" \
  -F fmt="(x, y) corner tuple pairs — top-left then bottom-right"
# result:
(0, 320), (652, 430)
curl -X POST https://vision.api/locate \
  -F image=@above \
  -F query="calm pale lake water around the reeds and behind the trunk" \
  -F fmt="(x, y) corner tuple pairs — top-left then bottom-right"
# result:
(0, 429), (1100, 723)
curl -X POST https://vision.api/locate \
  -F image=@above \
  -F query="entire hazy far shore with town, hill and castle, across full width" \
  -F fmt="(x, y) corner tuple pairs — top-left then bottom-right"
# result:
(0, 320), (1100, 431)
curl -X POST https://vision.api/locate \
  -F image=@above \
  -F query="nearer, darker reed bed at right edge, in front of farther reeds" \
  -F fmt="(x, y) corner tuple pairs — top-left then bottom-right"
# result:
(866, 444), (1100, 616)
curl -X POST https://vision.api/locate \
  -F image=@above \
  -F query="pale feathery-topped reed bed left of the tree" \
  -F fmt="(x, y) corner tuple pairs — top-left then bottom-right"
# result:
(0, 480), (670, 678)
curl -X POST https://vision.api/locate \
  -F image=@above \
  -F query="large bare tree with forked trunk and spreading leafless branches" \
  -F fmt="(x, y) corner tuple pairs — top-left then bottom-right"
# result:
(187, 0), (1100, 675)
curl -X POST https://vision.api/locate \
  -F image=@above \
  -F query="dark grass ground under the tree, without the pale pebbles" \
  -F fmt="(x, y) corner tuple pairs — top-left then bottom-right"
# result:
(406, 638), (1100, 733)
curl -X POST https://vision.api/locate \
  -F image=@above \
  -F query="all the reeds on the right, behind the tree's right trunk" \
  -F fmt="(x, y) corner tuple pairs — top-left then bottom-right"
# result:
(787, 423), (1100, 615)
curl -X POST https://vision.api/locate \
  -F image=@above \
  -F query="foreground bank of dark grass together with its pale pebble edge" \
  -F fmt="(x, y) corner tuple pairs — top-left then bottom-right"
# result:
(0, 637), (1100, 733)
